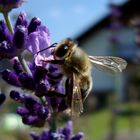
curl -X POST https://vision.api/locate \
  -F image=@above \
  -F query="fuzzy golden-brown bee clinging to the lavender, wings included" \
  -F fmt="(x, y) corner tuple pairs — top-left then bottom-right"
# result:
(40, 38), (127, 116)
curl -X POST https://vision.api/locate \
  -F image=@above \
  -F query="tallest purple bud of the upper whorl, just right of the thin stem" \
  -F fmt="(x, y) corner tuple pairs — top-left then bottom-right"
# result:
(15, 12), (28, 28)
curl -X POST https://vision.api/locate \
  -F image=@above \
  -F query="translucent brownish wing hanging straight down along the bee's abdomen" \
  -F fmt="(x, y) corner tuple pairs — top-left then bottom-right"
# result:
(71, 73), (83, 117)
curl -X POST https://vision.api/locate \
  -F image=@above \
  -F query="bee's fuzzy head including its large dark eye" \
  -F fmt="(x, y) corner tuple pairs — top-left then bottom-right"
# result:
(53, 38), (77, 60)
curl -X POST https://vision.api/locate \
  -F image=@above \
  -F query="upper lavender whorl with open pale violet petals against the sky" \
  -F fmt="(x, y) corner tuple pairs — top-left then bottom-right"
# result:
(0, 13), (50, 59)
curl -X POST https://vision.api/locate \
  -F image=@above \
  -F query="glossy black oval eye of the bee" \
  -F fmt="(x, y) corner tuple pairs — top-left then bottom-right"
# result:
(55, 45), (68, 58)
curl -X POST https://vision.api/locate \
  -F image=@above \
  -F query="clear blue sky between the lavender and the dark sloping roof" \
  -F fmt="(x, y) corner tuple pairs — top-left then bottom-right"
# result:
(0, 0), (127, 43)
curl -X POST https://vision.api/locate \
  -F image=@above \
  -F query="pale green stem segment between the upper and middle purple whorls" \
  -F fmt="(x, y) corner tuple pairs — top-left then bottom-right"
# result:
(18, 54), (32, 75)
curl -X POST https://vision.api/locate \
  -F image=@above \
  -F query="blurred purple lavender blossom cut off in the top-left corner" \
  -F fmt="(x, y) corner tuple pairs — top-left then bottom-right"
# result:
(0, 0), (23, 13)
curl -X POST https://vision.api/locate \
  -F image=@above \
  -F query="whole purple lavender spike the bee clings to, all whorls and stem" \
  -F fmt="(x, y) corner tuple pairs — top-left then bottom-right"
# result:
(0, 0), (83, 140)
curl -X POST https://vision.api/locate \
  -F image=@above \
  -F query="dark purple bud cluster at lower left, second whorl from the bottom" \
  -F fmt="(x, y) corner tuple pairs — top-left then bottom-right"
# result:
(10, 91), (49, 127)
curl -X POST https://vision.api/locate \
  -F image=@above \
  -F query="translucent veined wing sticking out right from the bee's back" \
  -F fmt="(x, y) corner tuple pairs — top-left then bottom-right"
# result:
(89, 56), (127, 73)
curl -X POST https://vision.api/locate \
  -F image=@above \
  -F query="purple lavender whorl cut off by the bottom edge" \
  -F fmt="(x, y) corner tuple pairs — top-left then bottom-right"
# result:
(30, 121), (84, 140)
